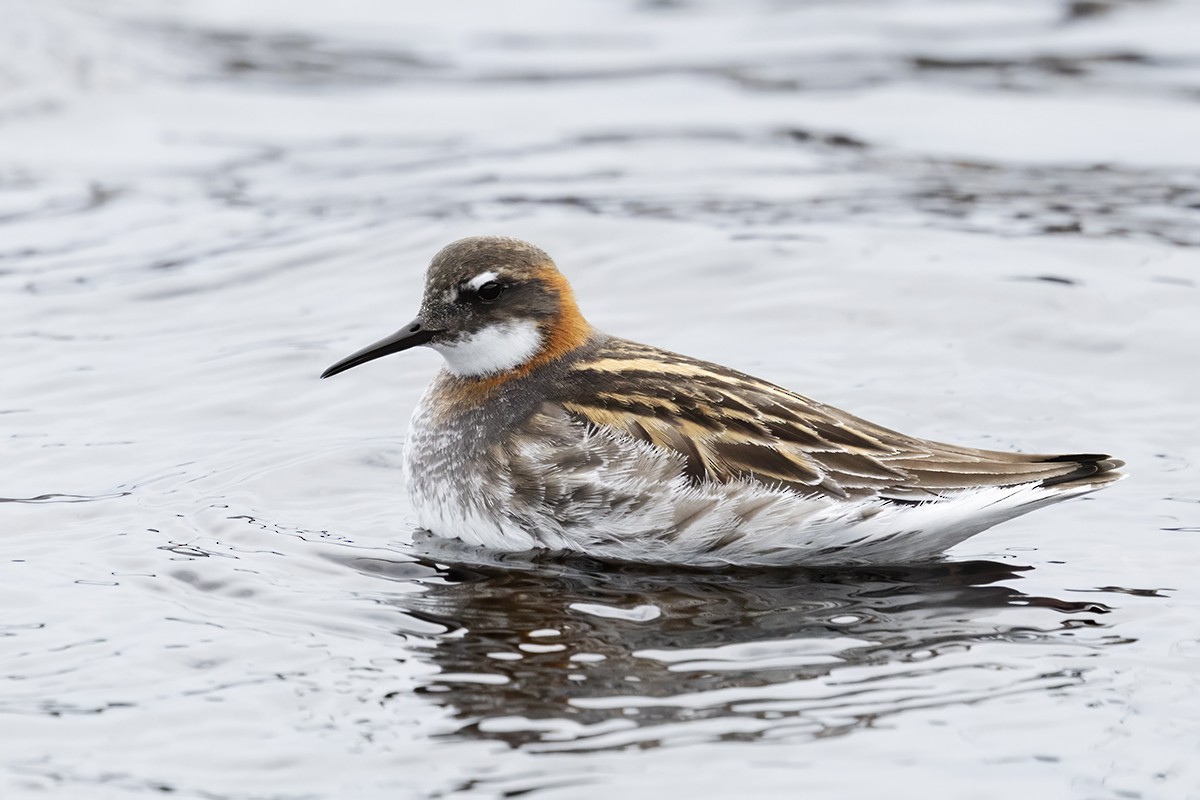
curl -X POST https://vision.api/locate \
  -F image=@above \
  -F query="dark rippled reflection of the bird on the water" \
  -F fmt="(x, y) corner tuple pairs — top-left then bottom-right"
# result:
(336, 542), (1117, 751)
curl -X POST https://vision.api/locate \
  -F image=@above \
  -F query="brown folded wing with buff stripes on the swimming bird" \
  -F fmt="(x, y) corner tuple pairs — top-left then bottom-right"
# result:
(552, 338), (1122, 501)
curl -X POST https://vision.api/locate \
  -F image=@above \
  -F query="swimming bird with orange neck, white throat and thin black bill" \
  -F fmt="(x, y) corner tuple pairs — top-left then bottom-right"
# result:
(322, 236), (1123, 569)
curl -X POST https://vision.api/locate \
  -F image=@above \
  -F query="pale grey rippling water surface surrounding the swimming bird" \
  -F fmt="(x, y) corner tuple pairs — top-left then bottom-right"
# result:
(0, 0), (1200, 800)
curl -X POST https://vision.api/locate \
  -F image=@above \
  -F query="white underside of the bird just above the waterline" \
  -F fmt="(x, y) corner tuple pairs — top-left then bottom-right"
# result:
(419, 483), (1087, 566)
